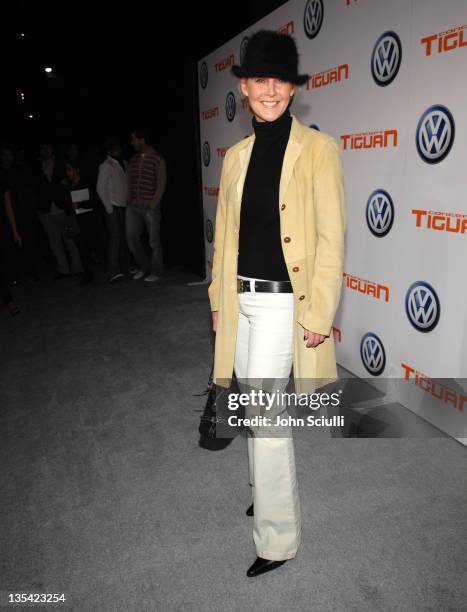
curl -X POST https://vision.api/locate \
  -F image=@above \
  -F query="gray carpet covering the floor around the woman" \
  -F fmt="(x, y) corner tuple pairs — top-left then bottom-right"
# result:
(0, 275), (467, 612)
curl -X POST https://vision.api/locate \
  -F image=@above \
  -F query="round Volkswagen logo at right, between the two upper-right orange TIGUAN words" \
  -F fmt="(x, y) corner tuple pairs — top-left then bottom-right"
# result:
(415, 104), (456, 164)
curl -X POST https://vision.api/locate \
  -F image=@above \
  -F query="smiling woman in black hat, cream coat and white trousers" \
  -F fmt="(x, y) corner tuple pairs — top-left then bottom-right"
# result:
(209, 30), (345, 577)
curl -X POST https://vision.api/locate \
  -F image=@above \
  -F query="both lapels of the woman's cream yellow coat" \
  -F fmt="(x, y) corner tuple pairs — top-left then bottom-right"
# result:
(236, 113), (303, 225)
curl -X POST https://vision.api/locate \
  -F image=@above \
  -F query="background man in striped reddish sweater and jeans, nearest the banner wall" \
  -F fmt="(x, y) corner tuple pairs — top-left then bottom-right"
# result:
(126, 129), (167, 282)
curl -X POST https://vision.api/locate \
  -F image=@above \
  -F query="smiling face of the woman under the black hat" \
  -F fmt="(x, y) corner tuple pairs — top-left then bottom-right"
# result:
(240, 77), (295, 121)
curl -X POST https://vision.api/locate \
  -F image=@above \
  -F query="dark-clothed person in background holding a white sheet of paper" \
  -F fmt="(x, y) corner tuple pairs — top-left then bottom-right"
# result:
(62, 161), (95, 285)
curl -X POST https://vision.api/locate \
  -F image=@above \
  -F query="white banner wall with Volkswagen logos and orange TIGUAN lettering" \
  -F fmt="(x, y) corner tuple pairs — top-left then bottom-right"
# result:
(198, 0), (467, 444)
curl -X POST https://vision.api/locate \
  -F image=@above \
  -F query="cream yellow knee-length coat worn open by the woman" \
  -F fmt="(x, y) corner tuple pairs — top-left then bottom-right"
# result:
(208, 114), (346, 393)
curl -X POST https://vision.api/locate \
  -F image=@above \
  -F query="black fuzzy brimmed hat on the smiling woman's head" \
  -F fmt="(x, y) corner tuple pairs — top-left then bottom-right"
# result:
(231, 30), (308, 85)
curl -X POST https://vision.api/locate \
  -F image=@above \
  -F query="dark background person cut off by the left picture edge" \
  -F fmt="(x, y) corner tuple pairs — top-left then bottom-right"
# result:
(0, 183), (21, 316)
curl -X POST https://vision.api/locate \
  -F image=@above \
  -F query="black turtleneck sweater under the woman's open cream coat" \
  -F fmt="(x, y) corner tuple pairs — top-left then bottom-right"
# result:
(237, 109), (292, 280)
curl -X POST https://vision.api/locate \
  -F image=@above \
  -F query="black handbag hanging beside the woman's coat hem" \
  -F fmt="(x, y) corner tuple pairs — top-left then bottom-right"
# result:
(198, 370), (243, 450)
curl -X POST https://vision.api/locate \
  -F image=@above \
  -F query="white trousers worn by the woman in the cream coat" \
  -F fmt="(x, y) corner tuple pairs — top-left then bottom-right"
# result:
(234, 276), (301, 561)
